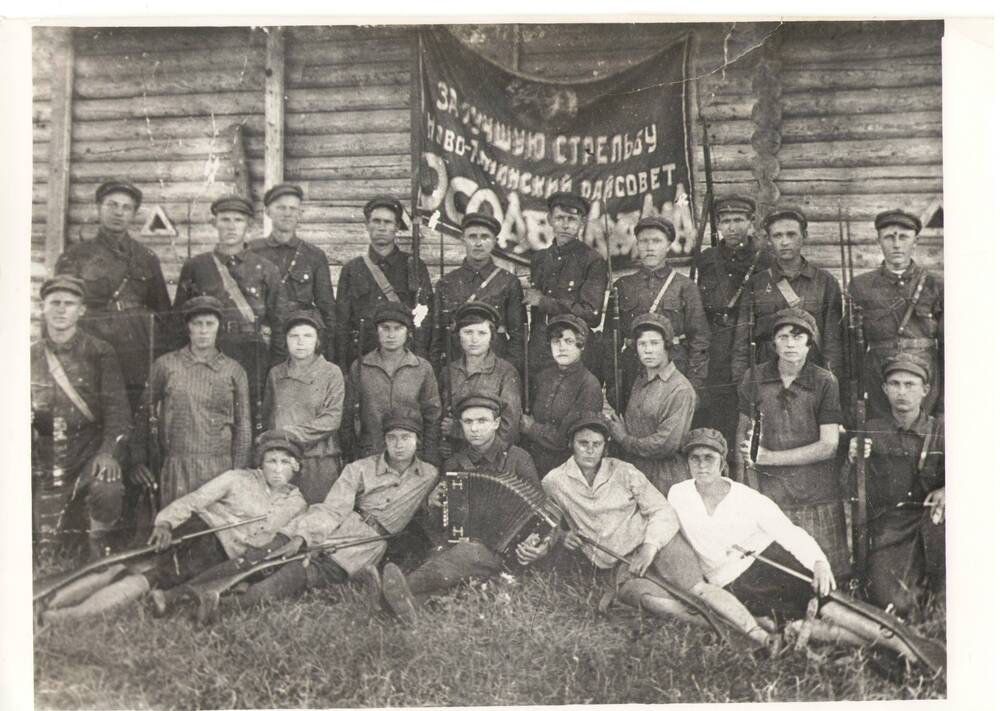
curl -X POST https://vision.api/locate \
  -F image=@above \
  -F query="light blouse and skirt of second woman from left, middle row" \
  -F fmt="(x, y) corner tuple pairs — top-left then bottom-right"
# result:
(264, 354), (344, 504)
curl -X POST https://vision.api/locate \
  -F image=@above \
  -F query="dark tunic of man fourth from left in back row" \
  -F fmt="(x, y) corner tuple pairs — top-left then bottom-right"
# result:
(337, 246), (434, 368)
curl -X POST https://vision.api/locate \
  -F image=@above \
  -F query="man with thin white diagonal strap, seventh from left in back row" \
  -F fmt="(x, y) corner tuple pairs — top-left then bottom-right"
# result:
(602, 217), (711, 412)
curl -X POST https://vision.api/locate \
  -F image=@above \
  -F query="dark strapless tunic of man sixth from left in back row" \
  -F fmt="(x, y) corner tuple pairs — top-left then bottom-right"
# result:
(528, 239), (608, 376)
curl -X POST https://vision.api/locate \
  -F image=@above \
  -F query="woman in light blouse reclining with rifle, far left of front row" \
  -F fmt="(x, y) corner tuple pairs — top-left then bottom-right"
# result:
(42, 431), (306, 622)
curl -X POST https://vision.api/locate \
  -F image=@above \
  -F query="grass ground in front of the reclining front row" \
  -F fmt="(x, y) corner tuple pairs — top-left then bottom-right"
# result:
(35, 560), (945, 709)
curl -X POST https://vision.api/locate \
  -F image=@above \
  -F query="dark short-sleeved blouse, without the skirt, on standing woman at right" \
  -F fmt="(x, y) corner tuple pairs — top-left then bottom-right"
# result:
(738, 358), (841, 507)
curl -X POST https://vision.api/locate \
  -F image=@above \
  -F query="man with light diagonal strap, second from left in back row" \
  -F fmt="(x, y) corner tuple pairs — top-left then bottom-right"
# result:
(174, 195), (281, 432)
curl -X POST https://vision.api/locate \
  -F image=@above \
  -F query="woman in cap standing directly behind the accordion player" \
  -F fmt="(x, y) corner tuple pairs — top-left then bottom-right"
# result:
(440, 301), (521, 456)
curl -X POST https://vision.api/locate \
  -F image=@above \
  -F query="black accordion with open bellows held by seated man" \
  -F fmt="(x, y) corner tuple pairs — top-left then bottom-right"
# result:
(441, 472), (562, 557)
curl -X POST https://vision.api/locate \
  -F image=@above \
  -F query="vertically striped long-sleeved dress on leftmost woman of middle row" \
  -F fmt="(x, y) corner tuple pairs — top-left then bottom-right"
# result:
(142, 346), (251, 505)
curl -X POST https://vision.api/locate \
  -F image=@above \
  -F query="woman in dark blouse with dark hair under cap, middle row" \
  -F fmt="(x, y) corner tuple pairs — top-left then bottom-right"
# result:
(521, 314), (604, 477)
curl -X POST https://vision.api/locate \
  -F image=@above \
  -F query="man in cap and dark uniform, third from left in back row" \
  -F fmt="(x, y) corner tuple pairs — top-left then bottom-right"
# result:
(249, 183), (337, 364)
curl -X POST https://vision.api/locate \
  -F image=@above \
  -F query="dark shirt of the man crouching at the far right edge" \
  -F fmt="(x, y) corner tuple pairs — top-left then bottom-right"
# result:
(865, 412), (944, 513)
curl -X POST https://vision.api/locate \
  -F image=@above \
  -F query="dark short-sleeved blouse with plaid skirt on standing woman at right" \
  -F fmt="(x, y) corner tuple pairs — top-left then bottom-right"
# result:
(739, 358), (850, 576)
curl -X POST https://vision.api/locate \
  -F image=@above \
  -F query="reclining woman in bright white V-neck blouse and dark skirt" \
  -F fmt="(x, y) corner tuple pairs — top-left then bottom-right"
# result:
(667, 428), (915, 661)
